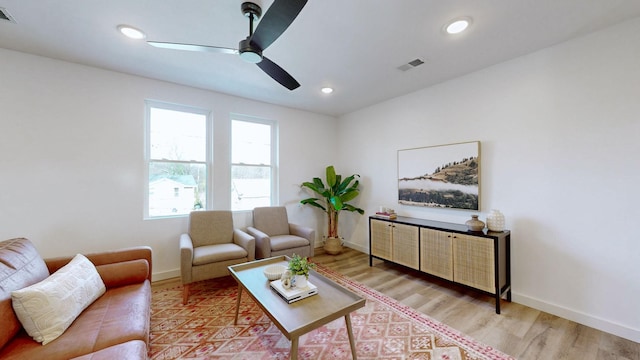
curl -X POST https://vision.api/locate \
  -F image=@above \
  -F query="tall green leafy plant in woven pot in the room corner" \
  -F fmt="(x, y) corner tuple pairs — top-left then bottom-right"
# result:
(300, 166), (364, 254)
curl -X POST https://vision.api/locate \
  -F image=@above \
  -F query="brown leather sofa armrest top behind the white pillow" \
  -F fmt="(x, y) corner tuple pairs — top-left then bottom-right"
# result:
(44, 246), (152, 282)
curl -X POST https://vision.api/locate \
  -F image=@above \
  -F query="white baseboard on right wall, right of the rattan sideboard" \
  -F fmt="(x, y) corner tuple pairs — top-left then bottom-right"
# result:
(512, 292), (640, 342)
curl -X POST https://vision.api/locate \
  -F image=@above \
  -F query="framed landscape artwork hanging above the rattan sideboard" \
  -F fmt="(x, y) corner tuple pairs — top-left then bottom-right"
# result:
(398, 141), (480, 210)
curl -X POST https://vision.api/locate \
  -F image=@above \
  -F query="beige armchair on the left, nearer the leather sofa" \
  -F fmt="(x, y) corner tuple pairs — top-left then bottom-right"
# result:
(180, 210), (255, 304)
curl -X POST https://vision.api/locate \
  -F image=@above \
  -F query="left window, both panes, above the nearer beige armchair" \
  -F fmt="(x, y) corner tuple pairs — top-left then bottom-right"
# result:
(145, 101), (211, 218)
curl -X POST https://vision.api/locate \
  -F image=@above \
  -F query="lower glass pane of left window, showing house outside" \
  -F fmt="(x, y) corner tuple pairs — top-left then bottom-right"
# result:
(149, 161), (207, 216)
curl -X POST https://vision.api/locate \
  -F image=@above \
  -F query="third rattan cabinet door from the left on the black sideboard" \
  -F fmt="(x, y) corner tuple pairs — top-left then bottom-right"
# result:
(420, 228), (453, 280)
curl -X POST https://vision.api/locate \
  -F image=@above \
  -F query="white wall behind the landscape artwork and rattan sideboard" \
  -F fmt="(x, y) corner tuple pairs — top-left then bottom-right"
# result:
(338, 19), (640, 342)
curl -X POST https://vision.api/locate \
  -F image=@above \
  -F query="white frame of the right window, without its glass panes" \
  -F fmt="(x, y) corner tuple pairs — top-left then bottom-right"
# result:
(229, 113), (279, 212)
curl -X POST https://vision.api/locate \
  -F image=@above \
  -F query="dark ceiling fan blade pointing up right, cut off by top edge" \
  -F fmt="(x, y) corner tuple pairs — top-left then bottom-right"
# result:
(251, 0), (307, 50)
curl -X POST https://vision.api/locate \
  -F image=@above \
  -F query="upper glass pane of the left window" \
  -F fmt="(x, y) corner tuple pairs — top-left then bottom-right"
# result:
(149, 107), (207, 162)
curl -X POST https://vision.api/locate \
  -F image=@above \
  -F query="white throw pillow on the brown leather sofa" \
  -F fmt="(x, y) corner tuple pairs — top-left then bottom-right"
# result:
(11, 254), (106, 345)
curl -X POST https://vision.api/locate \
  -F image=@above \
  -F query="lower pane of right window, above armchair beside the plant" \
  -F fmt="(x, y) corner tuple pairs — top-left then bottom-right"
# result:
(231, 165), (271, 210)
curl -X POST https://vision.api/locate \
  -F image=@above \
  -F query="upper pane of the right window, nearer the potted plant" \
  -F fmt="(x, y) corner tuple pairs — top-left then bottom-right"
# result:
(231, 120), (271, 165)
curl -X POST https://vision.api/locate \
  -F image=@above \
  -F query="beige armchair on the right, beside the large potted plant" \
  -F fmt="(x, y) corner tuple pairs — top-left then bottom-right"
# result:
(247, 206), (316, 259)
